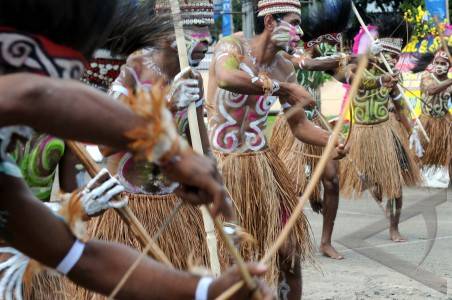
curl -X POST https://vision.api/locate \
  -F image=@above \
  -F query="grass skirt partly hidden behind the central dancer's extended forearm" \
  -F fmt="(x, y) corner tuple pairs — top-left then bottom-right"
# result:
(270, 115), (323, 212)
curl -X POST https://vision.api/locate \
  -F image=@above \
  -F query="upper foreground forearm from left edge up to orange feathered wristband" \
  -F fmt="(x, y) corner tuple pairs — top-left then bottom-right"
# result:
(0, 74), (145, 149)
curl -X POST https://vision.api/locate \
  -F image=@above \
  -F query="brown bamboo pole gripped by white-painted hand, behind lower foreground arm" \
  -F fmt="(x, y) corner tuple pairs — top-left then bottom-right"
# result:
(66, 141), (173, 267)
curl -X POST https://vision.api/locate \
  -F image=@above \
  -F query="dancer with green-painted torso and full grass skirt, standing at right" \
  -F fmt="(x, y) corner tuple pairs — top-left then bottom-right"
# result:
(340, 19), (421, 242)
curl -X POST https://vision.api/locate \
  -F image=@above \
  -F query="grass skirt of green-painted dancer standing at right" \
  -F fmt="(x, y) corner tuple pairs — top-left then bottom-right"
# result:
(339, 121), (421, 199)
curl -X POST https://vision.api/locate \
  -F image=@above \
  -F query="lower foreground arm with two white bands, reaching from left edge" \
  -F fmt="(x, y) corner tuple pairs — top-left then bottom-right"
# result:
(0, 174), (268, 299)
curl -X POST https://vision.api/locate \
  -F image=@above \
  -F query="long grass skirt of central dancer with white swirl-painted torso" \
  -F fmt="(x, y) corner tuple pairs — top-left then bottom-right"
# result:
(215, 149), (312, 286)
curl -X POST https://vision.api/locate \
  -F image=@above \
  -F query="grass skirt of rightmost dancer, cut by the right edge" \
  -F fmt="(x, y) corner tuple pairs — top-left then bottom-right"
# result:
(419, 113), (452, 168)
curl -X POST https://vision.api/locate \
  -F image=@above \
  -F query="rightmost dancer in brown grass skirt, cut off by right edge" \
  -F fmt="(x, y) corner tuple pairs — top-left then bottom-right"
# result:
(411, 49), (452, 176)
